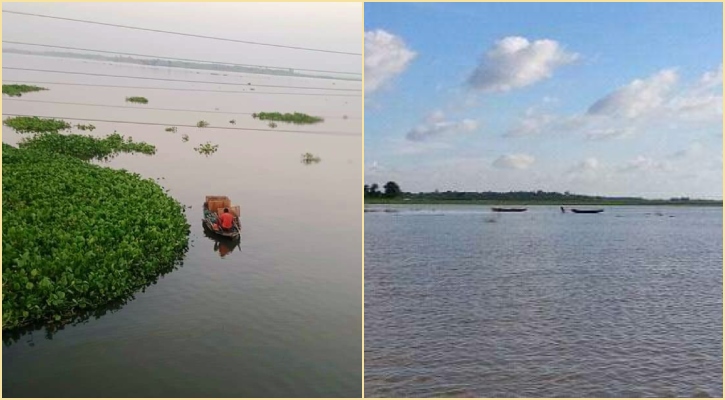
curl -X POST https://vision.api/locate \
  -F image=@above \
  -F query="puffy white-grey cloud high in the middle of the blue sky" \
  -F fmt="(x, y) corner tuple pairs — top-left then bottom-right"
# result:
(468, 36), (579, 92)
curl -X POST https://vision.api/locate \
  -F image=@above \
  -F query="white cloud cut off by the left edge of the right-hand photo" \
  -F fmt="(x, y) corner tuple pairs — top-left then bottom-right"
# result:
(365, 29), (416, 93)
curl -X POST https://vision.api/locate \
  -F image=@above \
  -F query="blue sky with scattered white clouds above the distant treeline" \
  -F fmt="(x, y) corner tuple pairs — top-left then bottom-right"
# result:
(365, 3), (723, 198)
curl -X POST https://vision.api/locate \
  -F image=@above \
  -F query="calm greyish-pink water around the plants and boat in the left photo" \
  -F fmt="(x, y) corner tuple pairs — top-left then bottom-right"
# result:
(3, 55), (362, 397)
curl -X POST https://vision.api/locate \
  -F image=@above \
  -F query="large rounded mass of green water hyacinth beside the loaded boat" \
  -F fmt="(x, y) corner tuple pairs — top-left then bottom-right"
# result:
(2, 143), (189, 330)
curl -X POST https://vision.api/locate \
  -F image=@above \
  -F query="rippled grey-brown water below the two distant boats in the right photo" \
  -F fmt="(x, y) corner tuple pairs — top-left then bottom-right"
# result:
(365, 206), (723, 397)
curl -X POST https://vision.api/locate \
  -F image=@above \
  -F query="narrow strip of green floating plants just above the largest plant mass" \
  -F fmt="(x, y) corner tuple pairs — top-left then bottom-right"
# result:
(18, 132), (156, 161)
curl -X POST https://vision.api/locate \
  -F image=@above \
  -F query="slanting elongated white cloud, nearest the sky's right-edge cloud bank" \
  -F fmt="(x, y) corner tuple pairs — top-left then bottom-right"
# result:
(588, 69), (677, 118)
